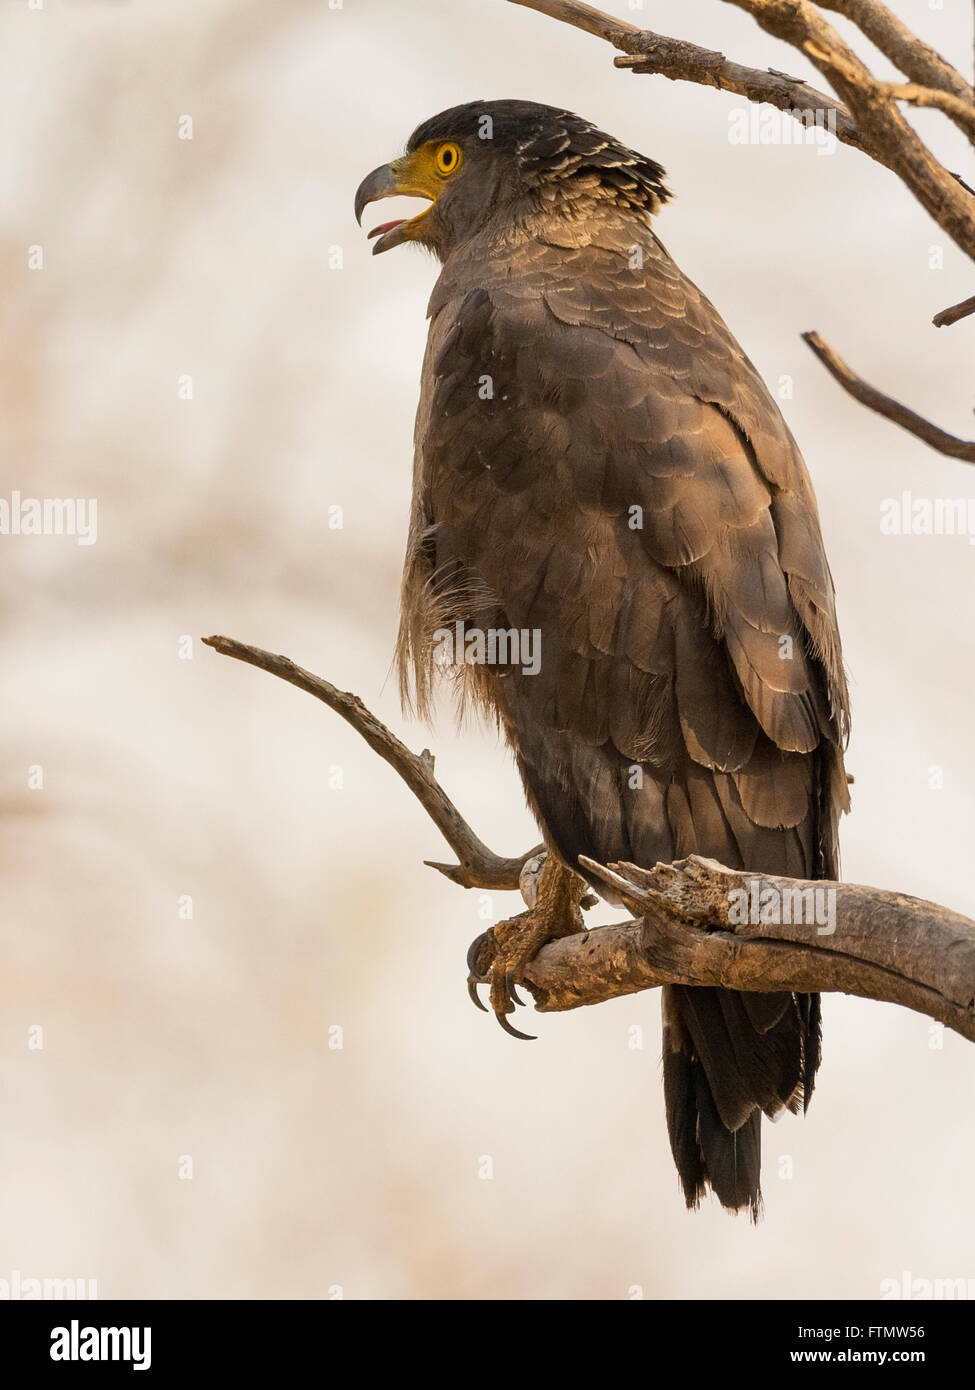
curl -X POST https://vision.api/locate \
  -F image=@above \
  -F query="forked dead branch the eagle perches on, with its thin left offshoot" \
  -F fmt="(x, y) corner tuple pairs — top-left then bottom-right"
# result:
(203, 637), (975, 1041)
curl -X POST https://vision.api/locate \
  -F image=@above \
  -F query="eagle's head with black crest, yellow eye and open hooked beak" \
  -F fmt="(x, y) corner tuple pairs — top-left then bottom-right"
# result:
(356, 101), (669, 260)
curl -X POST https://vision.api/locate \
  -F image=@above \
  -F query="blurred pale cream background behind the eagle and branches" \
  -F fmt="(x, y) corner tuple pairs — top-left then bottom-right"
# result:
(0, 0), (975, 1298)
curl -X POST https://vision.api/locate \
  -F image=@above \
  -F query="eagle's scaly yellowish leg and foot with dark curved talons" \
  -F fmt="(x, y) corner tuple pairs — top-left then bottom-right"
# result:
(467, 852), (588, 1040)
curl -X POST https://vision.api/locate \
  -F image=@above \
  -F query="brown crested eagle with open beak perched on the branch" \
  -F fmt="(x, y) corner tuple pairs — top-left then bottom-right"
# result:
(356, 100), (848, 1219)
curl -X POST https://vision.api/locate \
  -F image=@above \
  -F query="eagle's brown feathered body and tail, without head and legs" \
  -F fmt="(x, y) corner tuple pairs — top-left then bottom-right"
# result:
(401, 242), (847, 1205)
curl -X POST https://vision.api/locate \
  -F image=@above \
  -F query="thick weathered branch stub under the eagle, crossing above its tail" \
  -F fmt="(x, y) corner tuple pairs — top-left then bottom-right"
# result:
(524, 856), (975, 1041)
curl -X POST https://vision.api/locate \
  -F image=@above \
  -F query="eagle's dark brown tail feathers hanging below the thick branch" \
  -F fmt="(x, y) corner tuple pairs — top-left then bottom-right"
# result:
(663, 984), (819, 1220)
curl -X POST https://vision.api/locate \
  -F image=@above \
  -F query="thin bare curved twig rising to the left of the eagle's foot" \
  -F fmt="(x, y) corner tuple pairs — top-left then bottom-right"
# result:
(203, 637), (545, 890)
